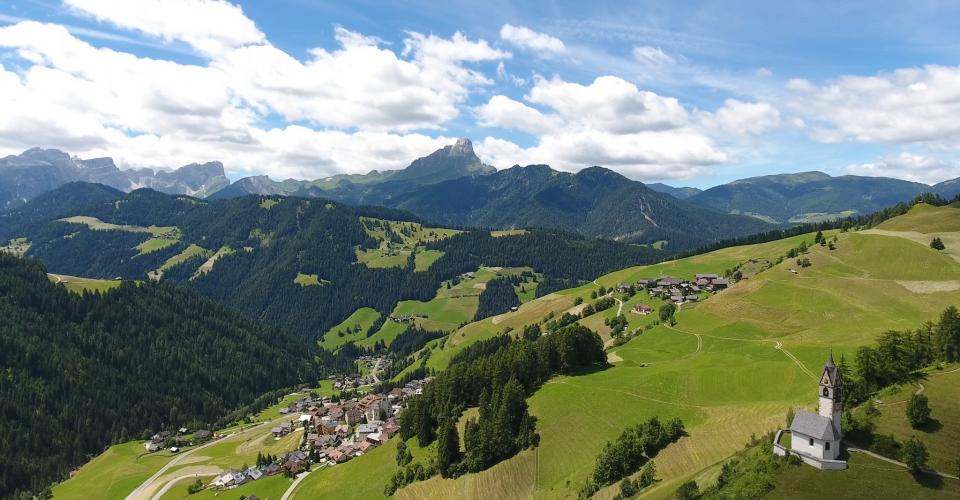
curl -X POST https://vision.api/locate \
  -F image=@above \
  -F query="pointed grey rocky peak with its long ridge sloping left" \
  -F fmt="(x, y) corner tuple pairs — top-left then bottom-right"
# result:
(211, 139), (496, 205)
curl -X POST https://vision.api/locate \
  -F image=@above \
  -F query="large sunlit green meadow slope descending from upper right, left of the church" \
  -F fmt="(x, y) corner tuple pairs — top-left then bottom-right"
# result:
(386, 205), (960, 498)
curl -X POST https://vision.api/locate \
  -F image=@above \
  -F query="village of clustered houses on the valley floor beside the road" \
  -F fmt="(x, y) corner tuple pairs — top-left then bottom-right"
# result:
(144, 376), (432, 489)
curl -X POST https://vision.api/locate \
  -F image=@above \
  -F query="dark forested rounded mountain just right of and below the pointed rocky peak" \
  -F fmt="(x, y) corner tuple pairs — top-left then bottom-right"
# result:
(386, 165), (772, 250)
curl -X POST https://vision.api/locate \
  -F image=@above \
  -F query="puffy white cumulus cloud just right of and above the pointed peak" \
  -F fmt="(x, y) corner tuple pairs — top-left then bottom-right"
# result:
(474, 76), (736, 179)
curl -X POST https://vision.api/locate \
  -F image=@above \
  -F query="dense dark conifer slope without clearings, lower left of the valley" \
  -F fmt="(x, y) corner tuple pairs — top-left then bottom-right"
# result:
(0, 253), (318, 497)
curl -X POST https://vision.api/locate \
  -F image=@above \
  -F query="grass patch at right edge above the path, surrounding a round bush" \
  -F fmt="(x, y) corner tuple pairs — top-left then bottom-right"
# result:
(873, 365), (960, 474)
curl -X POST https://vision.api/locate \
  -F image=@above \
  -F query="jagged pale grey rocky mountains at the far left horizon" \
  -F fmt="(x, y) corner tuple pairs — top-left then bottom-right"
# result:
(0, 148), (230, 209)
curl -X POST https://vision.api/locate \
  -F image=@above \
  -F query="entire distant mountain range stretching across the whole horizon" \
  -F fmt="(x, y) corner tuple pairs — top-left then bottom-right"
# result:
(0, 139), (960, 250)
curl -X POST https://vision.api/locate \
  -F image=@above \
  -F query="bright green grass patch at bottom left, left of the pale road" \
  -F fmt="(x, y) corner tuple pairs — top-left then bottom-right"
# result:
(53, 441), (180, 500)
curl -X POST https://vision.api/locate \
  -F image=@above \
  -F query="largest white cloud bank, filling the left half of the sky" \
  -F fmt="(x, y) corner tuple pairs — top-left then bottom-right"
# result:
(0, 9), (509, 178)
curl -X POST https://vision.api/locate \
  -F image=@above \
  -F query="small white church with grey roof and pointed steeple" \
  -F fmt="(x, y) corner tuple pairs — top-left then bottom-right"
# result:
(773, 353), (847, 470)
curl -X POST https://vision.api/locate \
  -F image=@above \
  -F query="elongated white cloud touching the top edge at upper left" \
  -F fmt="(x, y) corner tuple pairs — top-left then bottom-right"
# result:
(64, 0), (265, 55)
